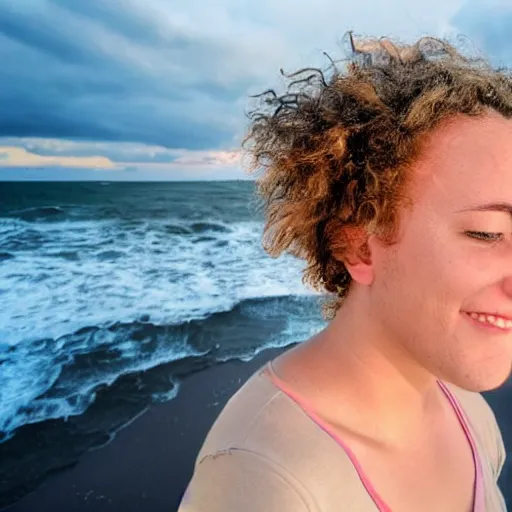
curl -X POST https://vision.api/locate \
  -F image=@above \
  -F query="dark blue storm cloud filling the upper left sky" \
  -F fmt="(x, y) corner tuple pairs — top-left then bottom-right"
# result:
(0, 0), (258, 149)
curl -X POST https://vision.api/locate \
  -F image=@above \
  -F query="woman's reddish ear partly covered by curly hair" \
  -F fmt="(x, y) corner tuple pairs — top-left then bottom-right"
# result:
(343, 227), (374, 285)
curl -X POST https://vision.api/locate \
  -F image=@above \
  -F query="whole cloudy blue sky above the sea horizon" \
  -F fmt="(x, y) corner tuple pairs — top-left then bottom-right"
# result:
(0, 0), (512, 180)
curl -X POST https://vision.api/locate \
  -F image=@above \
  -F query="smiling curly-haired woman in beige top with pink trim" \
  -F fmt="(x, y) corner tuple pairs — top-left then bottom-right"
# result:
(180, 36), (512, 512)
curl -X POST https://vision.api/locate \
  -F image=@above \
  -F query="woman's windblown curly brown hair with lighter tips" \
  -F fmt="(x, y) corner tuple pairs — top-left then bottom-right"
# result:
(242, 32), (512, 320)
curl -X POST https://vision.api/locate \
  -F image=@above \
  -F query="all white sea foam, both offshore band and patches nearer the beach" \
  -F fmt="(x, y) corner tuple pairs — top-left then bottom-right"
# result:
(0, 219), (320, 432)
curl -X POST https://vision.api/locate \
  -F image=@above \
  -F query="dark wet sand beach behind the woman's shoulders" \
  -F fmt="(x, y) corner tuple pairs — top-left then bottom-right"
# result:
(7, 344), (512, 512)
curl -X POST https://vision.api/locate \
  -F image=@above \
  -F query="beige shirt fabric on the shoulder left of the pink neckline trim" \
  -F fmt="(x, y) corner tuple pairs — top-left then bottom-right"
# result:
(184, 369), (371, 512)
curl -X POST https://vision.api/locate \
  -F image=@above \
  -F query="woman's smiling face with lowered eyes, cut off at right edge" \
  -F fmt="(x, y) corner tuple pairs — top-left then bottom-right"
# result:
(370, 114), (512, 391)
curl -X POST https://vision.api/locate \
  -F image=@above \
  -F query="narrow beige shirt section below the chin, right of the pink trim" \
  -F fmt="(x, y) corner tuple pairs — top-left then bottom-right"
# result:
(446, 384), (506, 479)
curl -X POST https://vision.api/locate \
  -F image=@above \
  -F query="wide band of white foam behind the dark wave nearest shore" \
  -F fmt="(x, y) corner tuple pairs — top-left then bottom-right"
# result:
(0, 218), (312, 344)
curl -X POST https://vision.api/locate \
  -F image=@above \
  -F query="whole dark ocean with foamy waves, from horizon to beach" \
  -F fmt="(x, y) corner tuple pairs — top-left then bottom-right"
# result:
(0, 181), (324, 506)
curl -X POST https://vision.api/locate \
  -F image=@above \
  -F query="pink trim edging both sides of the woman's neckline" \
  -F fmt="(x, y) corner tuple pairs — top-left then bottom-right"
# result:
(267, 361), (485, 512)
